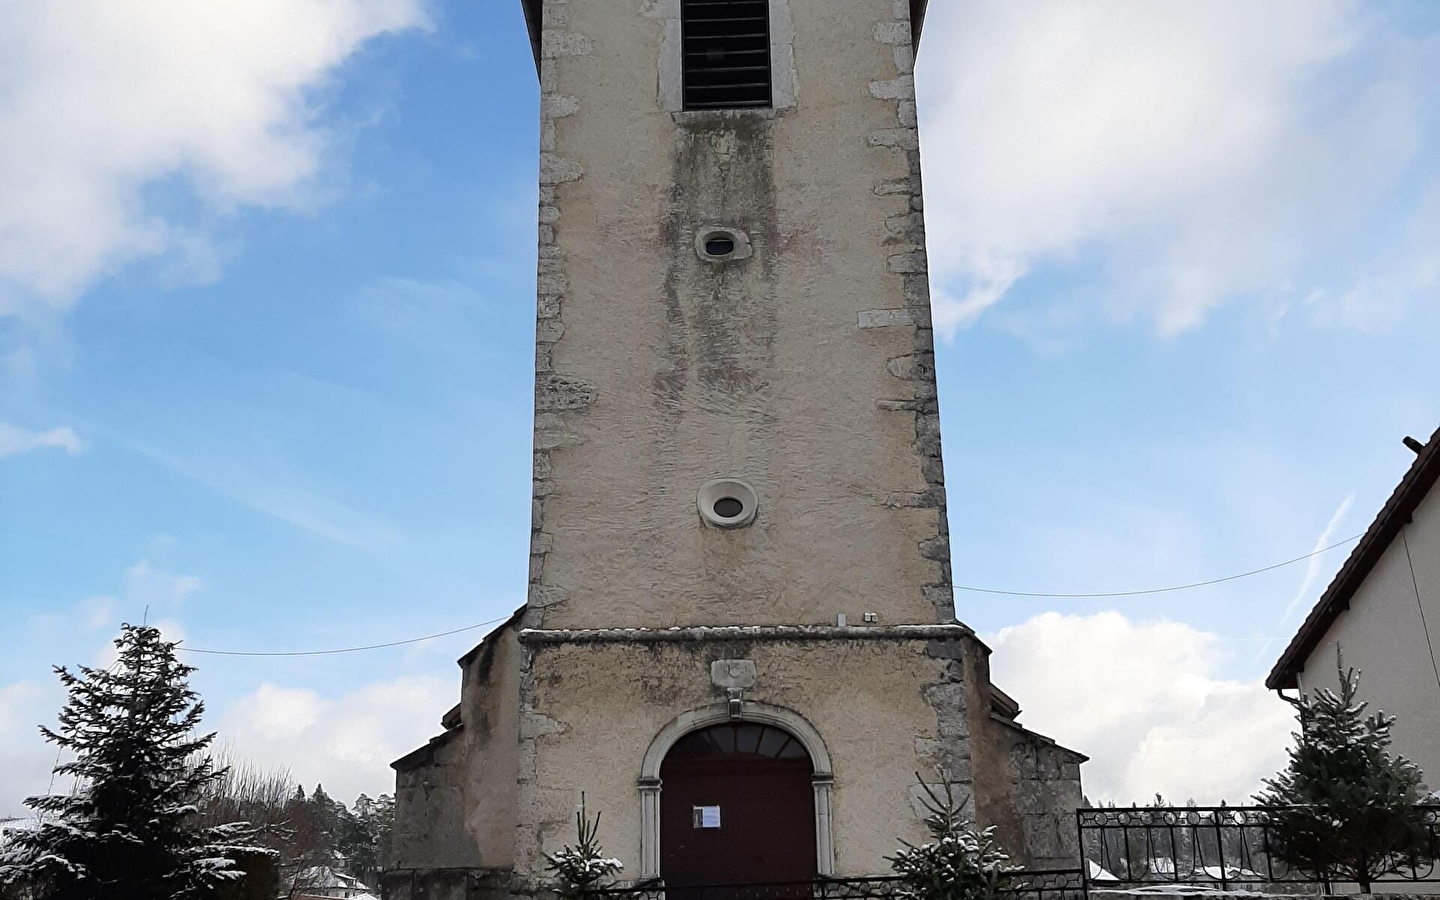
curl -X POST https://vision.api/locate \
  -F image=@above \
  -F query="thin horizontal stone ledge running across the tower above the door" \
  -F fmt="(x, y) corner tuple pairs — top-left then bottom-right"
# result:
(518, 624), (975, 644)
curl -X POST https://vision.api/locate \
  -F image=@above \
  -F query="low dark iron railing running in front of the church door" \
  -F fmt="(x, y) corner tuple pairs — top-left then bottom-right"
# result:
(585, 868), (1084, 900)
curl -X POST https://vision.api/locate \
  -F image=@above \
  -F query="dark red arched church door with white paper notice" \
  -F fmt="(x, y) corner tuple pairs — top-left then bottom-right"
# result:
(660, 721), (816, 888)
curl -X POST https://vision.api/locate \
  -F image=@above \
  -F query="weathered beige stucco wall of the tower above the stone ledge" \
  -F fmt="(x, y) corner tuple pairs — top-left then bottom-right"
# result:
(527, 0), (953, 628)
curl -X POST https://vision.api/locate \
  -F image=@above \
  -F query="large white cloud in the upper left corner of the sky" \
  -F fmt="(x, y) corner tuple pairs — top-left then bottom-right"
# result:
(0, 0), (426, 320)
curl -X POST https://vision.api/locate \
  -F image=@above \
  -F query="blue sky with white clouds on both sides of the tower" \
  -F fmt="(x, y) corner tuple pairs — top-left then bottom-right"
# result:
(0, 0), (1440, 816)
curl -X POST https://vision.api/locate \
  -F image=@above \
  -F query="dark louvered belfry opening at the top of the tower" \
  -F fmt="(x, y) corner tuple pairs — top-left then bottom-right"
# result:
(680, 0), (770, 109)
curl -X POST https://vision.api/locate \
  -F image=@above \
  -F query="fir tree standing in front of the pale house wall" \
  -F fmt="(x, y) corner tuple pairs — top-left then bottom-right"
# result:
(1256, 667), (1428, 893)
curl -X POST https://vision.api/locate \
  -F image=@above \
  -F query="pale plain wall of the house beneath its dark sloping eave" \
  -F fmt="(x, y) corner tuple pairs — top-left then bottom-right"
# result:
(1300, 491), (1440, 789)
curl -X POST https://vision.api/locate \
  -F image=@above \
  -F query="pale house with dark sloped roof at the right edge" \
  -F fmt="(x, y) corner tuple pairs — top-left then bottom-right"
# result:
(1266, 431), (1440, 788)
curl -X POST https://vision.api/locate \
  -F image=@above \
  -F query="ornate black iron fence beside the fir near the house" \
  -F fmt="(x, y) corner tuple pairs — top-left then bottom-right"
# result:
(1076, 806), (1440, 890)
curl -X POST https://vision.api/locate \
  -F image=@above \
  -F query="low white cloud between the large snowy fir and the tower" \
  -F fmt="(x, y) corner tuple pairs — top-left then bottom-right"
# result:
(219, 677), (456, 802)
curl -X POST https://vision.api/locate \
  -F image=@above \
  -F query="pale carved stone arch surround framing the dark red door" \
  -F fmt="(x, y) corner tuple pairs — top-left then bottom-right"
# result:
(639, 700), (835, 880)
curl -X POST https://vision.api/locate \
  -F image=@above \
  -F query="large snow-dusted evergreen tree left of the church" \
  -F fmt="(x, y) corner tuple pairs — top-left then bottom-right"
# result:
(0, 625), (269, 900)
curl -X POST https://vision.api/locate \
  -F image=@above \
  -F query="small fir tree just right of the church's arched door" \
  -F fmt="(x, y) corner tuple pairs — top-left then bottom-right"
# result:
(887, 769), (1015, 900)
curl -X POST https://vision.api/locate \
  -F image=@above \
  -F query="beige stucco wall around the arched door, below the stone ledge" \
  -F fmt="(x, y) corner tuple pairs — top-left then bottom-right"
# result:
(517, 641), (968, 877)
